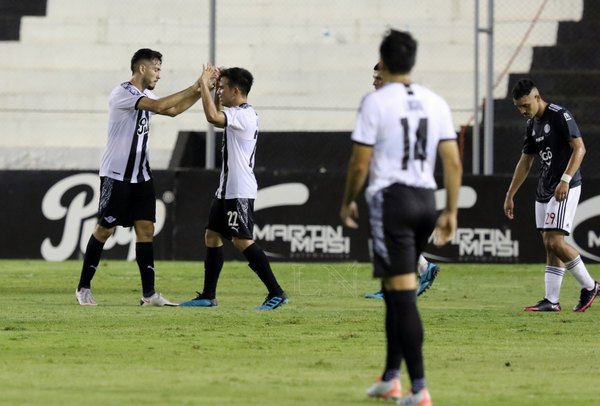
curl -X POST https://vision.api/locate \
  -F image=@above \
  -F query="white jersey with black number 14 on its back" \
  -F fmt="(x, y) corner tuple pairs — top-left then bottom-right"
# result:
(352, 83), (456, 197)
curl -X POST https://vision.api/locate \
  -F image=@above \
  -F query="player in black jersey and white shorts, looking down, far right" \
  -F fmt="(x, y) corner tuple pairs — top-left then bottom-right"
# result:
(504, 79), (598, 312)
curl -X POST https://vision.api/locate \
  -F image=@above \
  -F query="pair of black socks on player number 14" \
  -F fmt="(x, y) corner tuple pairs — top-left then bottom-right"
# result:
(384, 290), (425, 382)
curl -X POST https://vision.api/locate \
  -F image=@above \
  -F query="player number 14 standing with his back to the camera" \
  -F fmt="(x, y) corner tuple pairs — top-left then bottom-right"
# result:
(340, 30), (462, 406)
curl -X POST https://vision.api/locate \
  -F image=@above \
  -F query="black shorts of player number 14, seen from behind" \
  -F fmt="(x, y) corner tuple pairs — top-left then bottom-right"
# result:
(368, 183), (437, 278)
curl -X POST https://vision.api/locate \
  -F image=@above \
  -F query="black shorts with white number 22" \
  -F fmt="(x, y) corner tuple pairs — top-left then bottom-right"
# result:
(206, 197), (254, 240)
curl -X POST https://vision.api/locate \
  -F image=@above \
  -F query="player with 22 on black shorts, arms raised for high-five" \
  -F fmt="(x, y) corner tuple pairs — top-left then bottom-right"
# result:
(181, 64), (288, 310)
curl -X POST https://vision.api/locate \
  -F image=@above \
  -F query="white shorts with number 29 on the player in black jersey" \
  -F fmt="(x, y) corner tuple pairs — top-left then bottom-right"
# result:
(535, 186), (581, 235)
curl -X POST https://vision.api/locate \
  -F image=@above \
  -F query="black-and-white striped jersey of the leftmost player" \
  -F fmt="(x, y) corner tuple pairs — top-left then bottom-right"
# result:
(100, 82), (157, 183)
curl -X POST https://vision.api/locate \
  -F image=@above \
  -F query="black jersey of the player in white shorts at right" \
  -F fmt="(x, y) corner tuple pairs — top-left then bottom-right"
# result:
(523, 103), (581, 203)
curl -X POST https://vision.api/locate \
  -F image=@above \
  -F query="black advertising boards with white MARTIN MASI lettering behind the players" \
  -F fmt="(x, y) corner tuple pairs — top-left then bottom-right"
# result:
(0, 170), (600, 263)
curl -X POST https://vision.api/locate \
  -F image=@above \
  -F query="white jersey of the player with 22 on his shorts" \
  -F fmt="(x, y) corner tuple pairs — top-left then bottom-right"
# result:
(216, 103), (258, 199)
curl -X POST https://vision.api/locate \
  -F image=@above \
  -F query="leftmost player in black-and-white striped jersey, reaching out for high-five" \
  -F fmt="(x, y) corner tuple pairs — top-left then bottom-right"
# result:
(75, 48), (200, 306)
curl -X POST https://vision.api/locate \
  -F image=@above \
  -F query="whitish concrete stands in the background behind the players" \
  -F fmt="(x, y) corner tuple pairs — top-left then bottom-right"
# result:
(0, 0), (582, 169)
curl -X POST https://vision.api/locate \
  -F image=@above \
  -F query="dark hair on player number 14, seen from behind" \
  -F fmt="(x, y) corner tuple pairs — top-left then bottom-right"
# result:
(379, 29), (417, 74)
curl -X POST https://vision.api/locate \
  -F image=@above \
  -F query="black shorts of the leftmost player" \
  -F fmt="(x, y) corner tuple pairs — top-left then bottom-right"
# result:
(98, 177), (156, 228)
